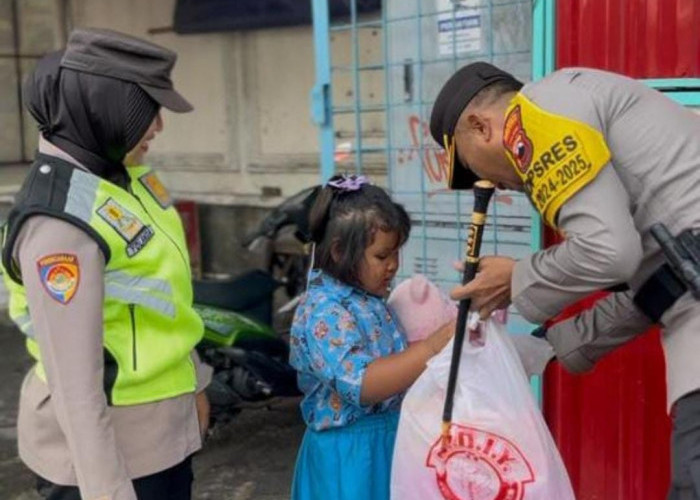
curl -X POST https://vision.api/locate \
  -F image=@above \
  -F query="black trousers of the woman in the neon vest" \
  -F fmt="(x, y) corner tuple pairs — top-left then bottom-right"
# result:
(37, 457), (193, 500)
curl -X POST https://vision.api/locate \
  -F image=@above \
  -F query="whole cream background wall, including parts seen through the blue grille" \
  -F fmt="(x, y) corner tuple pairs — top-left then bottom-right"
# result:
(0, 0), (385, 206)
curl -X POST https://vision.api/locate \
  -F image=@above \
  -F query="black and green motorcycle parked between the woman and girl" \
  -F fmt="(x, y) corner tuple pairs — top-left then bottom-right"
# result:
(193, 186), (320, 425)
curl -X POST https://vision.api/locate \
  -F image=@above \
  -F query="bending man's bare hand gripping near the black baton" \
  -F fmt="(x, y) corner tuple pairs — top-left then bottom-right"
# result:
(450, 257), (516, 319)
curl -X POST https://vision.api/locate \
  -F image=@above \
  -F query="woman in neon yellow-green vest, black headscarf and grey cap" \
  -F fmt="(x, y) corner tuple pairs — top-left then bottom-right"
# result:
(2, 30), (208, 500)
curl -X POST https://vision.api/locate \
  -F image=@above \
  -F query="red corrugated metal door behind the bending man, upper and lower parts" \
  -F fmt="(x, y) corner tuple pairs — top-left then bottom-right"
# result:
(544, 0), (700, 500)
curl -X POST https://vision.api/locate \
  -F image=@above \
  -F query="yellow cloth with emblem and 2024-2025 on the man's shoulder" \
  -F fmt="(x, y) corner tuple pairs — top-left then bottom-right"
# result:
(503, 93), (610, 227)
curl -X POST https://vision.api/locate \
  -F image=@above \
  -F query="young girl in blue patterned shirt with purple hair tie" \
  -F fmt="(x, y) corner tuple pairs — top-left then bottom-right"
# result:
(291, 176), (454, 500)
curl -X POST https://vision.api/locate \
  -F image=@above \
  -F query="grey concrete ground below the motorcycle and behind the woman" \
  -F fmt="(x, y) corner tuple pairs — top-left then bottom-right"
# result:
(0, 315), (304, 500)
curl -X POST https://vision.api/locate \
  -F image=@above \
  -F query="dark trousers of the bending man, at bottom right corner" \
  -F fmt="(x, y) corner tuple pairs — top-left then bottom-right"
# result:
(668, 391), (700, 500)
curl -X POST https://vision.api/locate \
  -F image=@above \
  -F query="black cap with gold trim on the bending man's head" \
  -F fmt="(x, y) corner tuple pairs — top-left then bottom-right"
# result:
(430, 61), (523, 189)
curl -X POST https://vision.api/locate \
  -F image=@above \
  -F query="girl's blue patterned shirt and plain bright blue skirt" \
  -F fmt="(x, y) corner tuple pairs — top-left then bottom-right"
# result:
(290, 271), (406, 500)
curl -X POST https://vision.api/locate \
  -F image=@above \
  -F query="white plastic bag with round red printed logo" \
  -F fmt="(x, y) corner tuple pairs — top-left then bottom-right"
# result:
(391, 319), (575, 500)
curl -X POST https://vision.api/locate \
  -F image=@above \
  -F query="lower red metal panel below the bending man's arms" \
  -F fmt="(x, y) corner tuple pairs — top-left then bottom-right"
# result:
(543, 294), (670, 500)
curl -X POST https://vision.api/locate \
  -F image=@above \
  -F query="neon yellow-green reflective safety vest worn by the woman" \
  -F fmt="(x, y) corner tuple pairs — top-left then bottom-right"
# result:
(3, 157), (204, 405)
